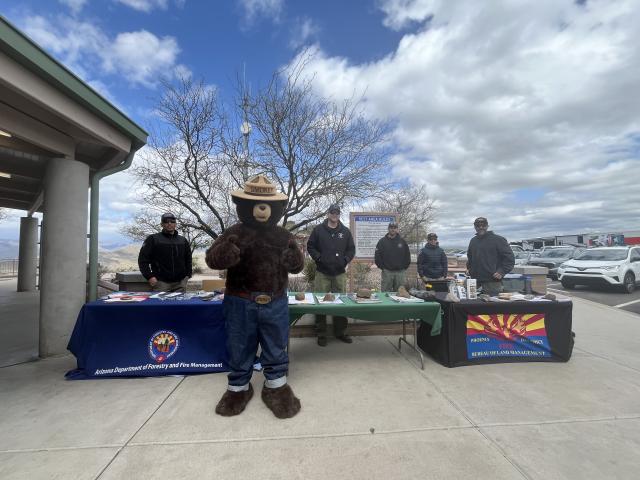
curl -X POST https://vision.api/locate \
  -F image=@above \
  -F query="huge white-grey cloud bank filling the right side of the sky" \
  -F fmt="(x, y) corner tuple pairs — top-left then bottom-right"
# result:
(292, 0), (640, 244)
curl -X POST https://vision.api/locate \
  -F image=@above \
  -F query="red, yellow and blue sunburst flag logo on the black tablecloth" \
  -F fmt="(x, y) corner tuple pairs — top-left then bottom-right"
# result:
(467, 313), (551, 360)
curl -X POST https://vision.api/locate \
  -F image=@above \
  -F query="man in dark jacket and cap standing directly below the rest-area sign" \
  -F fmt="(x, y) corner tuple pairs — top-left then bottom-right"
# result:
(375, 222), (411, 292)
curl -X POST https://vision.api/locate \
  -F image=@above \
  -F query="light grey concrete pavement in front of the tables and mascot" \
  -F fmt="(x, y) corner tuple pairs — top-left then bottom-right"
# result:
(0, 299), (640, 480)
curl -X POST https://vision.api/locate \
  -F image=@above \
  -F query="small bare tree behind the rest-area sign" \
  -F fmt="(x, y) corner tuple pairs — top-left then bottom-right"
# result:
(373, 185), (436, 248)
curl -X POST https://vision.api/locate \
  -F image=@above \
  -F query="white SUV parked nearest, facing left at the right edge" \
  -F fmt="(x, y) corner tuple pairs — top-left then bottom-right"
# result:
(558, 247), (640, 293)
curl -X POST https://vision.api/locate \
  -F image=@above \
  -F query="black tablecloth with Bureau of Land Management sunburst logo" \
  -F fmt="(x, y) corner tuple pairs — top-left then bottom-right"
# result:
(418, 294), (574, 367)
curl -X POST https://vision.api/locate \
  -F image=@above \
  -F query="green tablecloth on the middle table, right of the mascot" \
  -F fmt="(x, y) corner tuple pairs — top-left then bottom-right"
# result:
(289, 292), (442, 335)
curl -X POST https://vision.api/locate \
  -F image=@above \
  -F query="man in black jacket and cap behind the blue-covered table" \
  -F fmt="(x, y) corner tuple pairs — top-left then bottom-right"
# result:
(138, 213), (192, 292)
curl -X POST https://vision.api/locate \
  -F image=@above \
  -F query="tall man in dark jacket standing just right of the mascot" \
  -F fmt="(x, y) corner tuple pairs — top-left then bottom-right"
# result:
(307, 204), (356, 347)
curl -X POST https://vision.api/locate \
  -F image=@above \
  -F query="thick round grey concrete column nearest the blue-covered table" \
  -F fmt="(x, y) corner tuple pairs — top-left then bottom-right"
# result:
(40, 158), (89, 357)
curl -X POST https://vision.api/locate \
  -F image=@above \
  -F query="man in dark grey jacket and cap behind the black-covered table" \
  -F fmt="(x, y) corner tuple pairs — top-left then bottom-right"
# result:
(467, 217), (515, 296)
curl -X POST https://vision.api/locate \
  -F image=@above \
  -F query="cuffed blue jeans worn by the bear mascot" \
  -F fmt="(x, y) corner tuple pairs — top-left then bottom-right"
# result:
(223, 295), (289, 391)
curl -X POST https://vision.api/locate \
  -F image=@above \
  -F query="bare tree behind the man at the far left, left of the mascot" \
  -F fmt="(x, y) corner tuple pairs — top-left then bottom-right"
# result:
(132, 77), (239, 239)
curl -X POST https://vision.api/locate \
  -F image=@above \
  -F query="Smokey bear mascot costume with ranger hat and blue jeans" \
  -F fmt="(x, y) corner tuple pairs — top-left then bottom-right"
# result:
(206, 175), (304, 418)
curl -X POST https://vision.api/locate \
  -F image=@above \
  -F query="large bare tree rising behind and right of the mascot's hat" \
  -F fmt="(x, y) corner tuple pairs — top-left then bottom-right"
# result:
(249, 56), (389, 230)
